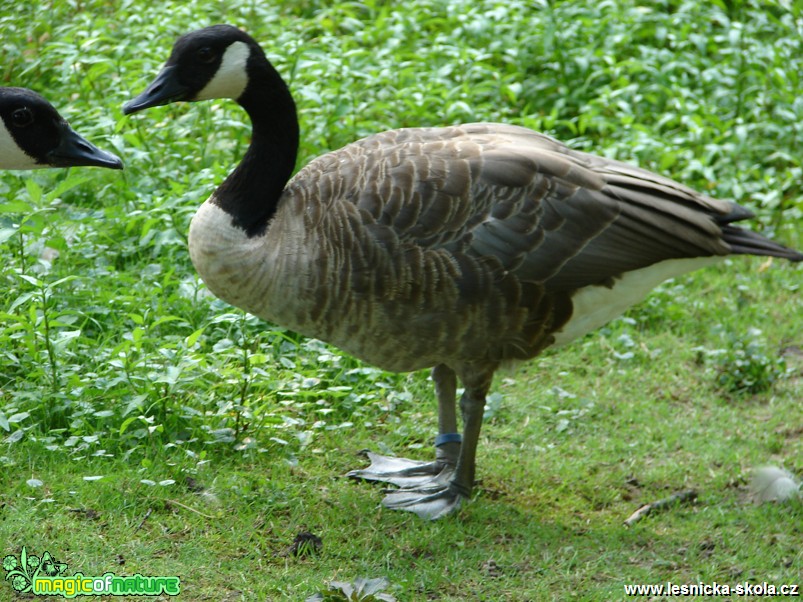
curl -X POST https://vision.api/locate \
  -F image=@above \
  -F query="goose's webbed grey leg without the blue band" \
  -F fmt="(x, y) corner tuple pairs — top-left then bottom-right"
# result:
(382, 370), (493, 520)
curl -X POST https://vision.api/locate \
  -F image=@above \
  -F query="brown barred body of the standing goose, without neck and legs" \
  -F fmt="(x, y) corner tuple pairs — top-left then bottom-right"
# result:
(190, 123), (801, 371)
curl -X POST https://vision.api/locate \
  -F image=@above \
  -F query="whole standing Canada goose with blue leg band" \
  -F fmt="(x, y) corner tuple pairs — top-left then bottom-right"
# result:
(124, 25), (803, 518)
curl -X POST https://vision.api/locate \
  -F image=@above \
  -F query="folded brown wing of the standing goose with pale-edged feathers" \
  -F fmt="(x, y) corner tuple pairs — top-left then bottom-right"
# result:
(310, 124), (778, 289)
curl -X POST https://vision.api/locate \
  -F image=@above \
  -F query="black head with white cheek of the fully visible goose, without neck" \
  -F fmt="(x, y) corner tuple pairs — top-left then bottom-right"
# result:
(123, 25), (266, 115)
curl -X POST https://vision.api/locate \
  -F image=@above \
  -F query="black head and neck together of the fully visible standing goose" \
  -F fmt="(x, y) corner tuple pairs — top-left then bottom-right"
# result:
(123, 25), (299, 235)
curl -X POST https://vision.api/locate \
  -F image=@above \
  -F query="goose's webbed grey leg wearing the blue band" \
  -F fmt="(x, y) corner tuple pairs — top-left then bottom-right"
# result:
(347, 364), (460, 487)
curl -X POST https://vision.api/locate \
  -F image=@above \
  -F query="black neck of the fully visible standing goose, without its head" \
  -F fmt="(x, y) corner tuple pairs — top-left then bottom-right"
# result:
(215, 56), (298, 236)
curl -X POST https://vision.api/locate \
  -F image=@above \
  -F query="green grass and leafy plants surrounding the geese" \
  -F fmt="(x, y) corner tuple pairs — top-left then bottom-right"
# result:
(0, 0), (803, 601)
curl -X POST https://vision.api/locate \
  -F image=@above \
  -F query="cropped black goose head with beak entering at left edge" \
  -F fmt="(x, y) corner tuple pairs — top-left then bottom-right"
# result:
(0, 87), (123, 169)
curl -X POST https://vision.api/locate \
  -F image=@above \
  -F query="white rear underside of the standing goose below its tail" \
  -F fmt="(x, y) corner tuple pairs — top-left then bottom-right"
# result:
(555, 256), (724, 347)
